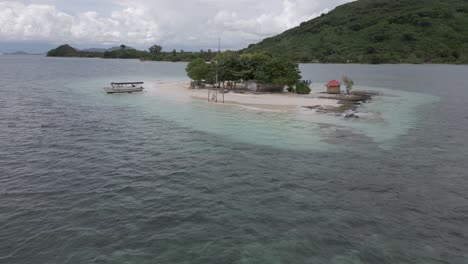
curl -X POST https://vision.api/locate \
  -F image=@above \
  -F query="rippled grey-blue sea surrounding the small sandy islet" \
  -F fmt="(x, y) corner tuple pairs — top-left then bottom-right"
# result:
(0, 56), (468, 264)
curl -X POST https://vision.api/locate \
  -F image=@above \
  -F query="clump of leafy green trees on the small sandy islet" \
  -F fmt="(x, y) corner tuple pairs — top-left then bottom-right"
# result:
(186, 51), (310, 94)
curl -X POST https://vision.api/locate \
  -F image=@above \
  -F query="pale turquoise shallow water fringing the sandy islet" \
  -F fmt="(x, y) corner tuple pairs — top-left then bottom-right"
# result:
(71, 77), (439, 151)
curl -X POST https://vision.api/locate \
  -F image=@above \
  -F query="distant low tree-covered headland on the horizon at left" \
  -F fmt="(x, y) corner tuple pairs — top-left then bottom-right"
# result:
(47, 44), (216, 62)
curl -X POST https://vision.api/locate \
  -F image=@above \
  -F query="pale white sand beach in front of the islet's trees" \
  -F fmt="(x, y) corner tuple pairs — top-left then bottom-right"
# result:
(146, 81), (339, 112)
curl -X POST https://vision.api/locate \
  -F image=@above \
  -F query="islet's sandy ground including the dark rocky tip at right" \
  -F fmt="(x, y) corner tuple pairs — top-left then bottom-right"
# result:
(146, 81), (374, 114)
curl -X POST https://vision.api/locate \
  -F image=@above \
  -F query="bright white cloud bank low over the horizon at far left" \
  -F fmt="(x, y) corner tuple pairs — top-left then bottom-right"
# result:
(0, 2), (160, 44)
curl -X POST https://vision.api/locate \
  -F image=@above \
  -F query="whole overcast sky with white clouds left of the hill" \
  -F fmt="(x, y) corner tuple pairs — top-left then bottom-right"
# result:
(0, 0), (350, 51)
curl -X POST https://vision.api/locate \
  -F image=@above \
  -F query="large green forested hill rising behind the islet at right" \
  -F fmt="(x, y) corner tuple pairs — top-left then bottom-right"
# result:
(242, 0), (468, 64)
